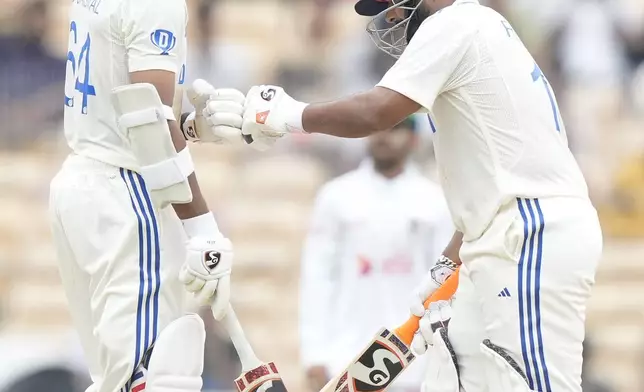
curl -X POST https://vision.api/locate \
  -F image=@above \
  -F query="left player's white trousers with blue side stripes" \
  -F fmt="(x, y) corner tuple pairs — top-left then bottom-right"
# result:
(50, 154), (185, 392)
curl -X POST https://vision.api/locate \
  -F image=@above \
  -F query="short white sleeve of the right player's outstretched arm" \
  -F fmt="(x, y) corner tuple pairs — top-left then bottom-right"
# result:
(378, 11), (474, 110)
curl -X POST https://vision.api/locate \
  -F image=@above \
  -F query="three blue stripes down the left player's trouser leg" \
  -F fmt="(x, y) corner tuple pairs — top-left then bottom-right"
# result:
(120, 168), (161, 392)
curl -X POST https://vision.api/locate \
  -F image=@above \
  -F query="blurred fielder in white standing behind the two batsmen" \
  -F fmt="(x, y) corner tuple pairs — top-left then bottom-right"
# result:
(300, 117), (454, 392)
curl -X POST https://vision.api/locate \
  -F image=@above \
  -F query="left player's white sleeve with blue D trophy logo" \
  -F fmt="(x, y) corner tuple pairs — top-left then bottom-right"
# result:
(123, 0), (188, 73)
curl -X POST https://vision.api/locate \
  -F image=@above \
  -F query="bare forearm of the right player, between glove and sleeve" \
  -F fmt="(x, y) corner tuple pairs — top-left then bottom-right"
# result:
(302, 93), (396, 138)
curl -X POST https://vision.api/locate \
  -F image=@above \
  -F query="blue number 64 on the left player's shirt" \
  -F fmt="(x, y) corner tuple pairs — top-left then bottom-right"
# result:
(65, 22), (96, 114)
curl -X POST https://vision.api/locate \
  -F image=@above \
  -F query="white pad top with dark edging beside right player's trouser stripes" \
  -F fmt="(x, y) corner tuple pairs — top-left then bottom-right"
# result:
(481, 340), (532, 392)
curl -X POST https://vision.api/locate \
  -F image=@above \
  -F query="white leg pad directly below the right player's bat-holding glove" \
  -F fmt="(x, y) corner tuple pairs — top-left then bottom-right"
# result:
(421, 328), (460, 392)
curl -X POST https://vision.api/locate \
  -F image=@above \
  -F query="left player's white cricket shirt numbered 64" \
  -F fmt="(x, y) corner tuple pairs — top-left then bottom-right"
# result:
(65, 0), (188, 170)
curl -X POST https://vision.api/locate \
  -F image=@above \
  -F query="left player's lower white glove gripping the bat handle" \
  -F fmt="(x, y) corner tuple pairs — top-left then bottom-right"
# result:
(179, 236), (233, 320)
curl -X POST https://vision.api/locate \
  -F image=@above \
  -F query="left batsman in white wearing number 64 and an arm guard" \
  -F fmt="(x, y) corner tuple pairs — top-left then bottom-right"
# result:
(50, 0), (244, 392)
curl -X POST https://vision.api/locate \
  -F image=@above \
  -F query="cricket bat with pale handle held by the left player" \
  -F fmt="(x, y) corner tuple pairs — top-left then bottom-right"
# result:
(216, 305), (287, 392)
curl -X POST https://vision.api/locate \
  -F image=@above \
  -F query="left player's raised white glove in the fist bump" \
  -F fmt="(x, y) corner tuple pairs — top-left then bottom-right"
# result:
(181, 79), (245, 144)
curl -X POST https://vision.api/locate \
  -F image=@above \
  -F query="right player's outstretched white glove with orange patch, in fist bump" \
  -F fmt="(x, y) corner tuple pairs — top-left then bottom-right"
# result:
(242, 85), (307, 149)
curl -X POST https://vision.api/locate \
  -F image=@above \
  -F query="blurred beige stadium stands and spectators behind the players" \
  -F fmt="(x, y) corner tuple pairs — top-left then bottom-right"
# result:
(0, 0), (644, 392)
